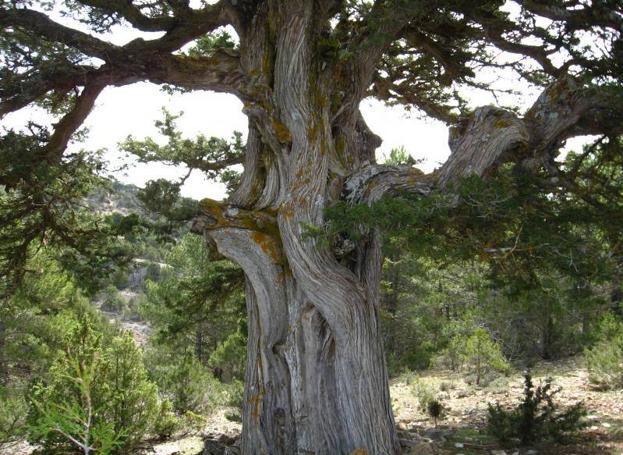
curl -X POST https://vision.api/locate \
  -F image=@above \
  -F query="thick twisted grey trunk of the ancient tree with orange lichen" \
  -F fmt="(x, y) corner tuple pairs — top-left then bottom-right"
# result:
(194, 0), (400, 455)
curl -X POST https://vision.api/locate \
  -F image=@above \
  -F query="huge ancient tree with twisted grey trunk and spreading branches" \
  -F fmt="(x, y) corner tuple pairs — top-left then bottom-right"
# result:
(0, 0), (623, 454)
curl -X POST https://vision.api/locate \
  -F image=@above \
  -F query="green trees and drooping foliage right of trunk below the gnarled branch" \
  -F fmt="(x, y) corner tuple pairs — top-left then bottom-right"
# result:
(336, 142), (623, 376)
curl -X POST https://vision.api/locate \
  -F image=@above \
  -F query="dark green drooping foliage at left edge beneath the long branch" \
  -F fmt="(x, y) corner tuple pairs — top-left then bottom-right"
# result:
(0, 134), (133, 296)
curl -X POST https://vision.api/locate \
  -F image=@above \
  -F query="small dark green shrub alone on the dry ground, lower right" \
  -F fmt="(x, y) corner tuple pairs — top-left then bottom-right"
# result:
(487, 374), (586, 445)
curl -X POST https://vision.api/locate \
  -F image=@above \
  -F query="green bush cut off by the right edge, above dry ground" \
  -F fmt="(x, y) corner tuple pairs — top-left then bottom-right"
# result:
(585, 316), (623, 389)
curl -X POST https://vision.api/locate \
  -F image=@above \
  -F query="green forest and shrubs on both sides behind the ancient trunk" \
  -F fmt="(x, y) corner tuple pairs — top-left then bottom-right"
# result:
(0, 140), (623, 453)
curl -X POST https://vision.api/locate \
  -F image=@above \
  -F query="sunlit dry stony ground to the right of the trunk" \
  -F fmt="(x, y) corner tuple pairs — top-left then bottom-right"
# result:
(391, 358), (623, 455)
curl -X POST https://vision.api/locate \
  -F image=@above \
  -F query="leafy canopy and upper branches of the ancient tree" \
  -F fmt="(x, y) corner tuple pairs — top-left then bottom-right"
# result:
(0, 0), (623, 278)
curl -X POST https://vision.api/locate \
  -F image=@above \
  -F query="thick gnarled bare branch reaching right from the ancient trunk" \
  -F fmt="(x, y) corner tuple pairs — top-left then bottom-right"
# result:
(344, 77), (623, 203)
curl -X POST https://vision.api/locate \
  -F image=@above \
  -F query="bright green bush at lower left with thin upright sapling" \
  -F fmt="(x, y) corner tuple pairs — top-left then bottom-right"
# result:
(28, 314), (158, 454)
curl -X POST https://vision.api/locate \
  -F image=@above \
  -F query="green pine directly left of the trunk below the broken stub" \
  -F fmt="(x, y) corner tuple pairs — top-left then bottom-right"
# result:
(140, 234), (246, 386)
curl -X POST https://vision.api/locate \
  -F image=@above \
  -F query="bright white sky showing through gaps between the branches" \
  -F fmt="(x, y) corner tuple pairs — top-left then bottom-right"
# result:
(2, 2), (581, 199)
